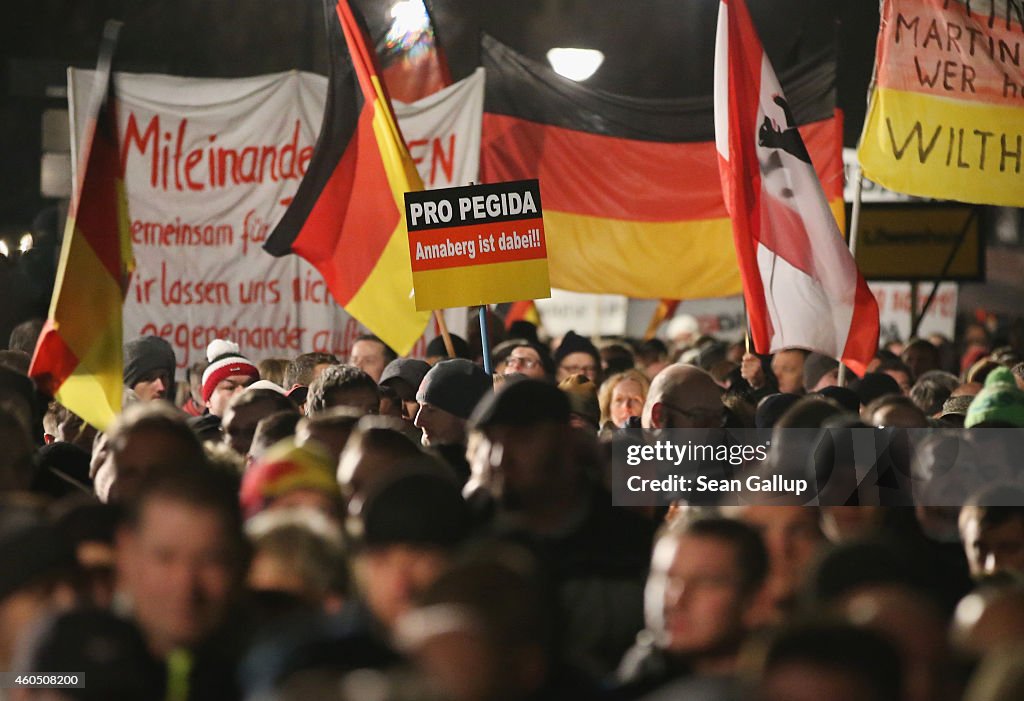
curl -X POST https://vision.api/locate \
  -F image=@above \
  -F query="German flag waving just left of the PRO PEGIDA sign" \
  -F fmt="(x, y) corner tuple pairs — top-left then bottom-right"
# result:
(264, 0), (429, 355)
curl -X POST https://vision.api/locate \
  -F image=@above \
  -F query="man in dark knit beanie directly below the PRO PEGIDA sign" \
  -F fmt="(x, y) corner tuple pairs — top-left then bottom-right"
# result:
(414, 358), (492, 481)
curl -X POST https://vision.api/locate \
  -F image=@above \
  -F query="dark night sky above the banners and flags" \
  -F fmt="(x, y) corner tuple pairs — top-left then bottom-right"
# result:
(0, 0), (878, 233)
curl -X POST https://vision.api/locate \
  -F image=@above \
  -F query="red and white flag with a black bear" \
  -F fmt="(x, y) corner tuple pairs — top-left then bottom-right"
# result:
(715, 0), (879, 375)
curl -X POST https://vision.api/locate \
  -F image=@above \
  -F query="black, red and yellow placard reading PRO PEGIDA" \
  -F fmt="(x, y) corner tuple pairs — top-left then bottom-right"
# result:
(406, 180), (551, 310)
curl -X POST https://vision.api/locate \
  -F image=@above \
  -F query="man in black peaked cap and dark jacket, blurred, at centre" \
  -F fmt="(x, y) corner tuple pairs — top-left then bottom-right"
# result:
(470, 380), (653, 677)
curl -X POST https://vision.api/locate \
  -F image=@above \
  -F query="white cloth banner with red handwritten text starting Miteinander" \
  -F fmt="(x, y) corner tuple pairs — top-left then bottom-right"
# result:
(68, 69), (483, 367)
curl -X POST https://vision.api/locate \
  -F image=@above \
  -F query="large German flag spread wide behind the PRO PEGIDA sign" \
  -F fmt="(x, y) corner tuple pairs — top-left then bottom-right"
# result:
(480, 36), (843, 299)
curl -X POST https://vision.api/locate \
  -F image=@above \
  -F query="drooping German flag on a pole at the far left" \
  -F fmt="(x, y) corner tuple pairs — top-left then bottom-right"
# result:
(29, 23), (134, 431)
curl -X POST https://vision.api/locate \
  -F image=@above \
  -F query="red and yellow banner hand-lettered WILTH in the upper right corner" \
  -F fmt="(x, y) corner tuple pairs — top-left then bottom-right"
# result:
(858, 0), (1024, 207)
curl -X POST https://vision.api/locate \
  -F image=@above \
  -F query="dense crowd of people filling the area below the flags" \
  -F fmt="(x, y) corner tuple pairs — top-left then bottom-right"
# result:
(0, 321), (1024, 701)
